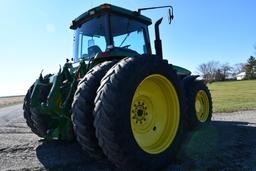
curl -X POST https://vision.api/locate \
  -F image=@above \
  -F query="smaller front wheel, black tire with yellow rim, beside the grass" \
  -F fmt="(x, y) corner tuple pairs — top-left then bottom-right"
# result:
(186, 81), (212, 130)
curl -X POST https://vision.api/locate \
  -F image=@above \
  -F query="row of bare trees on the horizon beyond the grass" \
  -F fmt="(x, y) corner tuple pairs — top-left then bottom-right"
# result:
(197, 56), (256, 82)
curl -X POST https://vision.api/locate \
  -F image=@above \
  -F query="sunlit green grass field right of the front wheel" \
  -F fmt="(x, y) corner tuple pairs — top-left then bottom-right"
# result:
(208, 80), (256, 112)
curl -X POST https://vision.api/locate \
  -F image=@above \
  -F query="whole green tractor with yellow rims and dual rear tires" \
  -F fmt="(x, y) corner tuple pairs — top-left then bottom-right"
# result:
(23, 4), (212, 170)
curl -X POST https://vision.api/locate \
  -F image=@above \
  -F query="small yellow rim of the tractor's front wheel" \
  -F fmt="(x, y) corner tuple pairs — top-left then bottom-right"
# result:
(195, 90), (210, 122)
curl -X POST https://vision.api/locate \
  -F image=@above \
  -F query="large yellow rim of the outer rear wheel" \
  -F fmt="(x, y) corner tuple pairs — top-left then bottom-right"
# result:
(130, 74), (180, 154)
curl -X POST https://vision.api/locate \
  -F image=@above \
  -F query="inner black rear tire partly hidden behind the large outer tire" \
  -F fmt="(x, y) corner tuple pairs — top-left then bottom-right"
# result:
(72, 61), (116, 159)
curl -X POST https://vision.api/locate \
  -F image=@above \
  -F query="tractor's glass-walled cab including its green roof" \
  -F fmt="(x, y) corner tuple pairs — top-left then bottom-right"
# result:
(70, 4), (152, 62)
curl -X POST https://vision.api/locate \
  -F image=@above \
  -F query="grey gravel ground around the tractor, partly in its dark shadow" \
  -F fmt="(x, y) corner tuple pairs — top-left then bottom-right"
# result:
(0, 105), (256, 171)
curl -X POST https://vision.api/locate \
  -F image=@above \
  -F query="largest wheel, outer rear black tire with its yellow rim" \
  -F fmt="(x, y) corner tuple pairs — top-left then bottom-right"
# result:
(94, 55), (184, 170)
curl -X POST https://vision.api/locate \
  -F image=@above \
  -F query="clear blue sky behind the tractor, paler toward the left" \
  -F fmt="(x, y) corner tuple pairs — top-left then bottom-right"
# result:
(0, 0), (256, 96)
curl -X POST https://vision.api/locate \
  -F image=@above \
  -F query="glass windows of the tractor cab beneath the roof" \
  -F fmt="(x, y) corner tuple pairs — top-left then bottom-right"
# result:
(74, 14), (150, 62)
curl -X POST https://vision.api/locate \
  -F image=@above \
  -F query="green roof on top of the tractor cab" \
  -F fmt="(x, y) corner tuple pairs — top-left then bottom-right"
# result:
(70, 4), (152, 29)
